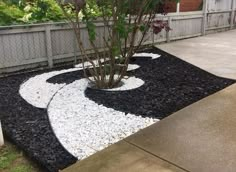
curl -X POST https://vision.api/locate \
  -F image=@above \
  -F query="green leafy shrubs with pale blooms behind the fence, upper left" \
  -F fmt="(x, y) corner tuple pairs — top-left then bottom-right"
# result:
(0, 0), (109, 25)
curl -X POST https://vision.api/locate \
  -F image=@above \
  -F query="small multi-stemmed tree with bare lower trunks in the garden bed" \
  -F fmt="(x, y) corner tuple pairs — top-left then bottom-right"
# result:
(59, 0), (169, 89)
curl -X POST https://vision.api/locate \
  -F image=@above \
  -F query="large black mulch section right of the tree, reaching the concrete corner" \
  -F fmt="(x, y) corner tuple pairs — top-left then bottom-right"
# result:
(86, 48), (235, 119)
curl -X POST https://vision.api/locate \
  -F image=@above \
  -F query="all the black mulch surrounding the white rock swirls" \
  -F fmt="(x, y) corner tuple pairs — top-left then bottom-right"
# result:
(0, 48), (235, 172)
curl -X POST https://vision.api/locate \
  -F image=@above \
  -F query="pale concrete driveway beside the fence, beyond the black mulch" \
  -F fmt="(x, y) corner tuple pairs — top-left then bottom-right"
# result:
(157, 30), (236, 79)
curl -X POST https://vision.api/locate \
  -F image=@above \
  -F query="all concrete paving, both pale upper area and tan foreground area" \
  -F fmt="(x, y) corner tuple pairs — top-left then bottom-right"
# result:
(63, 30), (236, 172)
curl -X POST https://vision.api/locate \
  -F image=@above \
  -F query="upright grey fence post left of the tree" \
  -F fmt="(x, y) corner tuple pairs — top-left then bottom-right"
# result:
(45, 26), (53, 68)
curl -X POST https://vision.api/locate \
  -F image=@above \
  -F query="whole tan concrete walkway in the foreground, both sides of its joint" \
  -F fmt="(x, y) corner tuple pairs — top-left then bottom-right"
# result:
(64, 84), (236, 172)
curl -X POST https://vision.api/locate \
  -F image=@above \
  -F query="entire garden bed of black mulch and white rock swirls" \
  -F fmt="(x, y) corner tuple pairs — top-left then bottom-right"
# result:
(0, 48), (235, 171)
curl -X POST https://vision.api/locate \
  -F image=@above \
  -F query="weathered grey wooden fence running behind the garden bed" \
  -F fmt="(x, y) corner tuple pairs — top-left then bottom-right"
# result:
(0, 0), (236, 74)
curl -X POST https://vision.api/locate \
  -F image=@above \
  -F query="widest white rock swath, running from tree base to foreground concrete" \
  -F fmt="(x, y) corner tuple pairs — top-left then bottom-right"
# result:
(48, 78), (158, 159)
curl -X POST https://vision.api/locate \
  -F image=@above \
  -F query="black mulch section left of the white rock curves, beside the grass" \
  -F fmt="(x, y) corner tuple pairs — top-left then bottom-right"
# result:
(0, 68), (76, 172)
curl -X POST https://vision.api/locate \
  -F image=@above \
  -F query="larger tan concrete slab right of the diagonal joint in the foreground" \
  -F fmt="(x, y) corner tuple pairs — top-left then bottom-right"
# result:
(126, 85), (236, 172)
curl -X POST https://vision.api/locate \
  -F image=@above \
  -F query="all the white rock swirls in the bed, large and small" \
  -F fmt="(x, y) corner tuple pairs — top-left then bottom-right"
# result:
(19, 53), (160, 159)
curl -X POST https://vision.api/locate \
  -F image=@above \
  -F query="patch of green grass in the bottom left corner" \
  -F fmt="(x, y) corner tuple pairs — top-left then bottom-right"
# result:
(0, 142), (43, 172)
